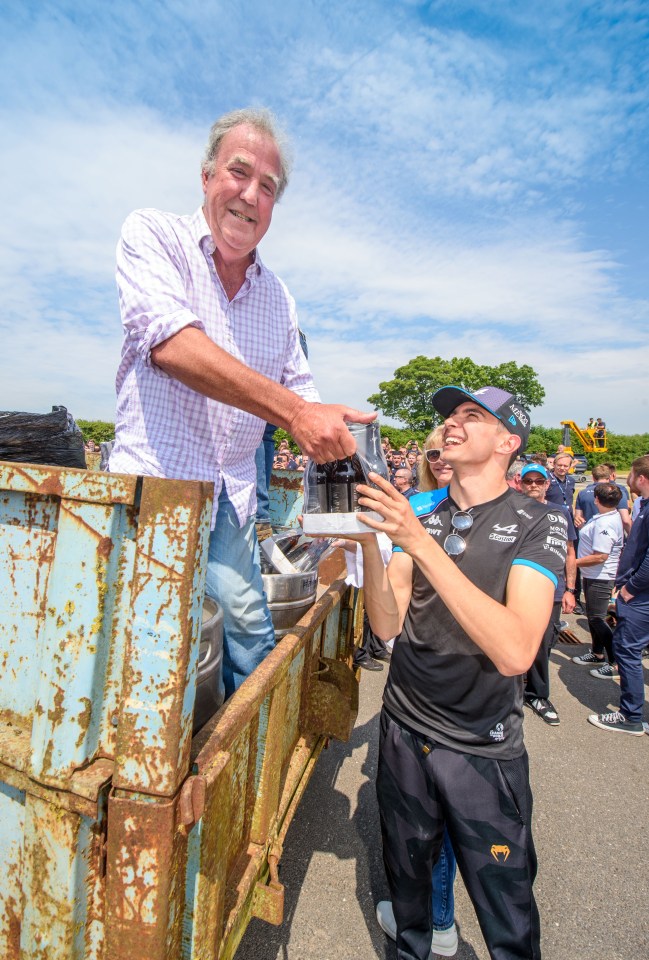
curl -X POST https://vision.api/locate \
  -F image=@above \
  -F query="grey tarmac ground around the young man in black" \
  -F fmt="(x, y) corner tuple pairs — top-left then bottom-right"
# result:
(236, 616), (649, 960)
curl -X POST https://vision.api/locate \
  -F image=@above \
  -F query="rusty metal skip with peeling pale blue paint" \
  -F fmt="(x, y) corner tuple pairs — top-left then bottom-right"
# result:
(0, 463), (361, 960)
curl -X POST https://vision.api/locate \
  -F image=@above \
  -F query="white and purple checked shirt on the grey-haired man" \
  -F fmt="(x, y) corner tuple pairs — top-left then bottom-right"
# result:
(110, 208), (320, 527)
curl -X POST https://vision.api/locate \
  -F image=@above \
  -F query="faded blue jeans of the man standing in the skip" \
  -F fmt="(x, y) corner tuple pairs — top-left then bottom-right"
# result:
(205, 485), (275, 697)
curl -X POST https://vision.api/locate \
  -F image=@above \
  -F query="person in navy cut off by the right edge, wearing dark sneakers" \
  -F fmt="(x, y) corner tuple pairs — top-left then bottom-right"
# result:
(588, 456), (649, 736)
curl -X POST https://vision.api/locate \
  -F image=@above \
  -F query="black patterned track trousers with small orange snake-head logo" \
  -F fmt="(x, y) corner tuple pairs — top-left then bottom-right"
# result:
(376, 710), (541, 960)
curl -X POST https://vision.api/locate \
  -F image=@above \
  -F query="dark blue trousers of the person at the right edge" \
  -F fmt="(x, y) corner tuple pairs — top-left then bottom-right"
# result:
(613, 597), (649, 723)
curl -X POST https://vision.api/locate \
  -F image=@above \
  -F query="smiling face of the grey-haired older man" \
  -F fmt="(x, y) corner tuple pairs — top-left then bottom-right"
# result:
(202, 124), (281, 263)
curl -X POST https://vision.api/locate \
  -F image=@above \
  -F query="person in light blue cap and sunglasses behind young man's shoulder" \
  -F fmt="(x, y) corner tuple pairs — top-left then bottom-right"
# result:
(521, 463), (577, 727)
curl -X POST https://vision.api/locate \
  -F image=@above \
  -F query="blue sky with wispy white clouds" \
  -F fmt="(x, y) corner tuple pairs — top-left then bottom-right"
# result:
(0, 0), (649, 433)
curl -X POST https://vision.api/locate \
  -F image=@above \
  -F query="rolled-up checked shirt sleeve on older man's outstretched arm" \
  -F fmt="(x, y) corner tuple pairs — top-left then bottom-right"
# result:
(117, 210), (205, 377)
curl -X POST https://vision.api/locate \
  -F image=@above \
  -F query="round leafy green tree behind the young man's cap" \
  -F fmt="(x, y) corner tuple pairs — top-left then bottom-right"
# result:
(367, 356), (545, 433)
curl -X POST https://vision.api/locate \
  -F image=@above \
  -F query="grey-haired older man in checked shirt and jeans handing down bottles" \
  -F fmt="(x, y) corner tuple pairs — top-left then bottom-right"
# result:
(110, 109), (375, 696)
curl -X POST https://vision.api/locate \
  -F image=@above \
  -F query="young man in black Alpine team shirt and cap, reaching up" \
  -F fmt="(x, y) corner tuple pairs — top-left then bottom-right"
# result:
(350, 386), (567, 960)
